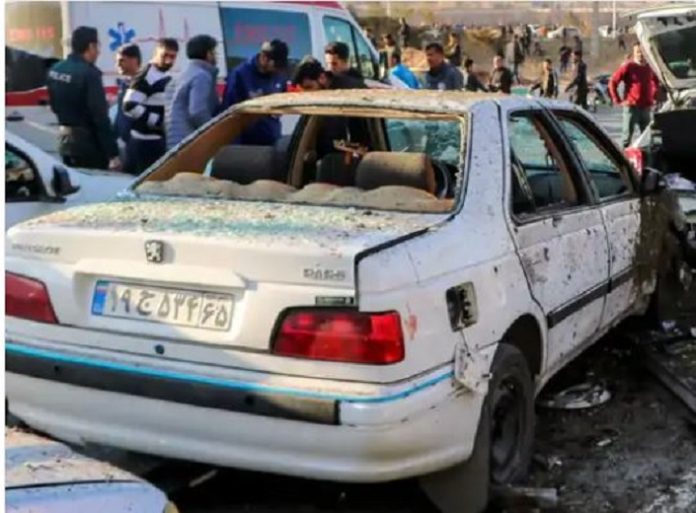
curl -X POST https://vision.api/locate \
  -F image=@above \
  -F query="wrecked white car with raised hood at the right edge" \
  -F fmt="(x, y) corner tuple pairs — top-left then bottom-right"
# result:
(626, 4), (696, 325)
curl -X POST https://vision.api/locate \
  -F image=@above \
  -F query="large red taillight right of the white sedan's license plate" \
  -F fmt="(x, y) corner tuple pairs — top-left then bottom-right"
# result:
(273, 309), (404, 365)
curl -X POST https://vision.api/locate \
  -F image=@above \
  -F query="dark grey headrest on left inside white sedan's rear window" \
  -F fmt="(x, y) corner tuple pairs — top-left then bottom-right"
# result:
(210, 145), (284, 185)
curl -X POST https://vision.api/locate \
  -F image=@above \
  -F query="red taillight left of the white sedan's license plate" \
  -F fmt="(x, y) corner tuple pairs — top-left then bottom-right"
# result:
(5, 272), (58, 324)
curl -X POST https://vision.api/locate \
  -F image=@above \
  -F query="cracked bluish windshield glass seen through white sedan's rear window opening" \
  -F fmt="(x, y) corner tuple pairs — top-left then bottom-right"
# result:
(385, 119), (461, 166)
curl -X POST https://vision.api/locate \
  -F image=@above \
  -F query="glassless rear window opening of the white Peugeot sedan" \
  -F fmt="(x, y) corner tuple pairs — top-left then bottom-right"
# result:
(136, 110), (465, 213)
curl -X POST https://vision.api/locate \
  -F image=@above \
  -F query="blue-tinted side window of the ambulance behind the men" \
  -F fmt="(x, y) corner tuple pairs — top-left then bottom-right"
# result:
(220, 7), (312, 75)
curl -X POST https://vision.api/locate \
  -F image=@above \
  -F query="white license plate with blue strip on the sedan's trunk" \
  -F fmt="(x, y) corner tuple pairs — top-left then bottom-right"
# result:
(92, 280), (234, 331)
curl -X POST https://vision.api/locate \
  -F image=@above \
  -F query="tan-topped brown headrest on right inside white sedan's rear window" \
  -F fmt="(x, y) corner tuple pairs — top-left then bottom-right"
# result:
(355, 151), (436, 194)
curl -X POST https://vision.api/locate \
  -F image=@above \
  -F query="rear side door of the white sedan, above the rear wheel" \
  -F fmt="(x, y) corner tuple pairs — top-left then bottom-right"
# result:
(506, 110), (609, 369)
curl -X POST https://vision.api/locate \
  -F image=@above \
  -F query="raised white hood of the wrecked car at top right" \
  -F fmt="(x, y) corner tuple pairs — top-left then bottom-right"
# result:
(636, 5), (696, 92)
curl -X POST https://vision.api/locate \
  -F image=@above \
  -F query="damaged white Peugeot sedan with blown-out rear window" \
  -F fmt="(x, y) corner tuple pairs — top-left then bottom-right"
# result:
(5, 91), (668, 502)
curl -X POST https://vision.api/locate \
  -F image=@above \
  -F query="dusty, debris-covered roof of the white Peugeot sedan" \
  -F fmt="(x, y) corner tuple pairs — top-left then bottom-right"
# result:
(239, 89), (548, 115)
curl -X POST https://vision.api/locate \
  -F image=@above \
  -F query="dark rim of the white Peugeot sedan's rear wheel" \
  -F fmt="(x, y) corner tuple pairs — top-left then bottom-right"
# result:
(491, 378), (525, 483)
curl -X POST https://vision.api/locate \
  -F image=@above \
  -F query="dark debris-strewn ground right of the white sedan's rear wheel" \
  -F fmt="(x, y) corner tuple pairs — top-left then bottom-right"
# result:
(531, 335), (696, 513)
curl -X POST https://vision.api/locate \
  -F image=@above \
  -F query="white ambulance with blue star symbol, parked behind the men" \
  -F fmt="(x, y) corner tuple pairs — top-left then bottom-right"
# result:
(5, 0), (379, 106)
